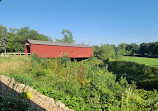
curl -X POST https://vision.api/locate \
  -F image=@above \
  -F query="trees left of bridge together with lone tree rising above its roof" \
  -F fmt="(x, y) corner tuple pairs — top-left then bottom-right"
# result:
(0, 25), (75, 53)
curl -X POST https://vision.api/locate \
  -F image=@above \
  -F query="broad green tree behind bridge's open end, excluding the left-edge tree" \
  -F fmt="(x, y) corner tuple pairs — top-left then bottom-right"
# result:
(8, 27), (52, 52)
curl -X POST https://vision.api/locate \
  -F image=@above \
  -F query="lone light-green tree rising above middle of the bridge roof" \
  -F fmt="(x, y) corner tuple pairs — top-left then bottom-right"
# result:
(56, 30), (75, 43)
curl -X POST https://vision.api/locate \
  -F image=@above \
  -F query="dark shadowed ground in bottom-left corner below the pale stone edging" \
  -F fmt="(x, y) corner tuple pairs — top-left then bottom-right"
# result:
(0, 81), (46, 111)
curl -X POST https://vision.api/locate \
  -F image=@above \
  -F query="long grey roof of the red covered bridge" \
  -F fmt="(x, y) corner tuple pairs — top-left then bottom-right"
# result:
(27, 39), (91, 47)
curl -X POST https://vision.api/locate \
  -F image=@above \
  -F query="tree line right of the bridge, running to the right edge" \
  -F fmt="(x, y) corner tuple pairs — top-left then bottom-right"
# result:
(93, 42), (158, 60)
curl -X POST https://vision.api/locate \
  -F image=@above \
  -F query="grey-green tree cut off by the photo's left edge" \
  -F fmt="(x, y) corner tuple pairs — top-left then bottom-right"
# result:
(0, 25), (8, 53)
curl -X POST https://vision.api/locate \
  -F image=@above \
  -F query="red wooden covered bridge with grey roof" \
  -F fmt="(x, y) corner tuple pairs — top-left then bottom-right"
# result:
(24, 39), (92, 58)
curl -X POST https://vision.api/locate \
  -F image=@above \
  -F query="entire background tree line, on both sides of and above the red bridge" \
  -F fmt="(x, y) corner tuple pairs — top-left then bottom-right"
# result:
(0, 25), (158, 60)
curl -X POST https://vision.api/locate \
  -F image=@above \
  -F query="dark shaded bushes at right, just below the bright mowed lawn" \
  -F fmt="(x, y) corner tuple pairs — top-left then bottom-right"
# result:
(108, 61), (158, 90)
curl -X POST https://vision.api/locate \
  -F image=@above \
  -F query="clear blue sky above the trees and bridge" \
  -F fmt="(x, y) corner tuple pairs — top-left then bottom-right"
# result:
(0, 0), (158, 45)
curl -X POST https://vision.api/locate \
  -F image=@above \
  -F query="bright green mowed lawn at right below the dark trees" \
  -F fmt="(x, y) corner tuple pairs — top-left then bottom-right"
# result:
(122, 56), (158, 67)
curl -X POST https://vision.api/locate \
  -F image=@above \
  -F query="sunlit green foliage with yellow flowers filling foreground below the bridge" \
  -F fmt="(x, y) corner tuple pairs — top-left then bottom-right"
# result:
(0, 55), (158, 111)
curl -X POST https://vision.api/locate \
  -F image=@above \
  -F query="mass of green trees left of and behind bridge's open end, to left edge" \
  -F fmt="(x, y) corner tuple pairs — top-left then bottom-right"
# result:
(0, 25), (52, 52)
